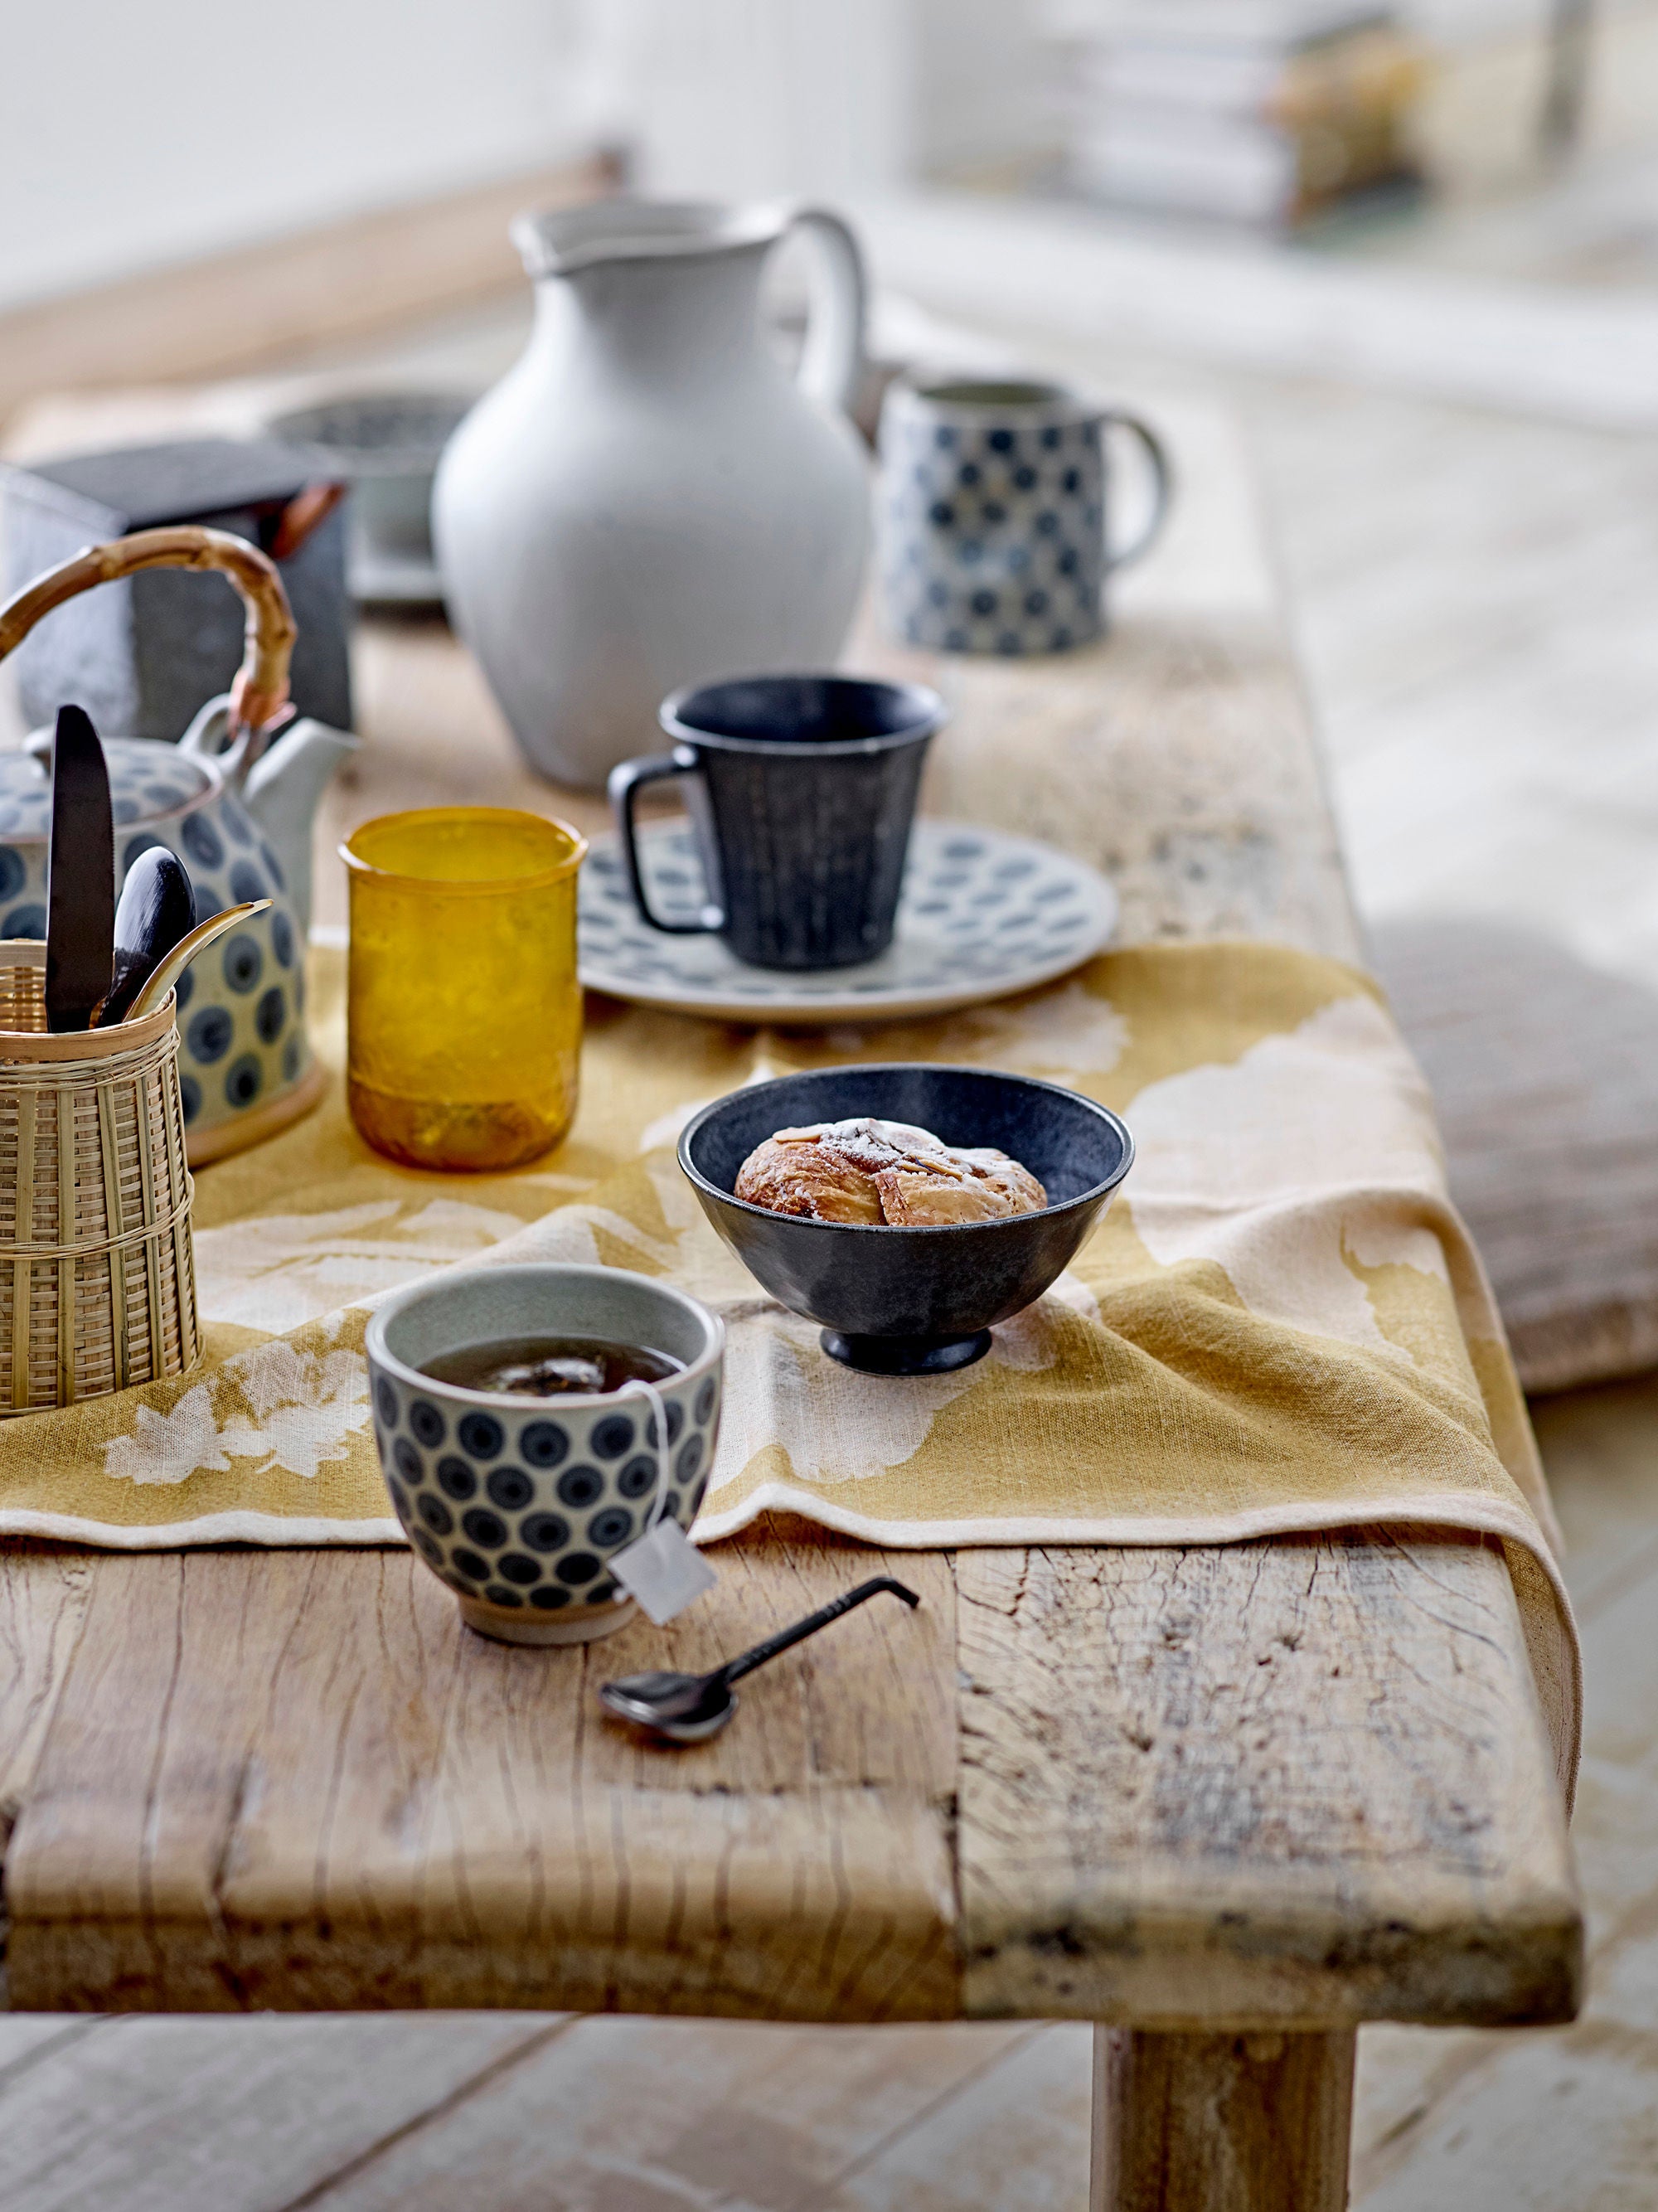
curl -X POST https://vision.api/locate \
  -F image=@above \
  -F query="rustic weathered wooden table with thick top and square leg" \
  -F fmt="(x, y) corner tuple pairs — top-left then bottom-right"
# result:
(0, 396), (1581, 2212)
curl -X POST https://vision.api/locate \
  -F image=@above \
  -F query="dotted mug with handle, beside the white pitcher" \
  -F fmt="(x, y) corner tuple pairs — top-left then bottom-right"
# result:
(878, 378), (1170, 655)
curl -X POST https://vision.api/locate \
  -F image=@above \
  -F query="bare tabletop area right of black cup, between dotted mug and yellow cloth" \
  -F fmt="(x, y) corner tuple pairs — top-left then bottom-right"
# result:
(924, 391), (1360, 960)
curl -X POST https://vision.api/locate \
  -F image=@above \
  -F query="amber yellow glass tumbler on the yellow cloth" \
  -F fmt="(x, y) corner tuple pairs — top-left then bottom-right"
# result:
(341, 808), (588, 1172)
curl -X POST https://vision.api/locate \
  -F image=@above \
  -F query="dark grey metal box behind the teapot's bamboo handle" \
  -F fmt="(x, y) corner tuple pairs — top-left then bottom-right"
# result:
(0, 438), (351, 743)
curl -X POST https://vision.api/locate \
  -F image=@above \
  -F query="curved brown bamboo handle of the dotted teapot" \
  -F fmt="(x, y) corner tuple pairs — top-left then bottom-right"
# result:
(0, 522), (298, 730)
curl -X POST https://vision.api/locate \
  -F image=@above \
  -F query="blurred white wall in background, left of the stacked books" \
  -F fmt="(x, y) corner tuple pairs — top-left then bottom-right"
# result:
(0, 0), (1065, 308)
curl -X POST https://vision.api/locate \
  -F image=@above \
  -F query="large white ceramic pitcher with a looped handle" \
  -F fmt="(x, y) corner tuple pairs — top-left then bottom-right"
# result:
(434, 199), (869, 788)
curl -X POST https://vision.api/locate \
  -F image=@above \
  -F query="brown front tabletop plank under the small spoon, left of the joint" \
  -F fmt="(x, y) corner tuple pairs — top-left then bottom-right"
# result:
(9, 1530), (955, 2020)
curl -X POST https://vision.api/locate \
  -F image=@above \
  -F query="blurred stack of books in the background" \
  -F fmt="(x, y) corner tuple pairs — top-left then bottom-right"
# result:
(1044, 0), (1423, 228)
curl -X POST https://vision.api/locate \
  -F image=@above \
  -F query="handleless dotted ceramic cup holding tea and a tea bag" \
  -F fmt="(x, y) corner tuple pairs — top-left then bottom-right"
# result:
(367, 1265), (725, 1643)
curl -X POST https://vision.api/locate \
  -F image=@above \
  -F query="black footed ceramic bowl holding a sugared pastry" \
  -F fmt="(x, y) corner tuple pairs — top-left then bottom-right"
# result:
(679, 1064), (1134, 1375)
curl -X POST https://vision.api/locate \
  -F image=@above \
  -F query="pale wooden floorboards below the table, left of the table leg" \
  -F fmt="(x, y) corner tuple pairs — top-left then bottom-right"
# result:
(0, 2013), (1088, 2212)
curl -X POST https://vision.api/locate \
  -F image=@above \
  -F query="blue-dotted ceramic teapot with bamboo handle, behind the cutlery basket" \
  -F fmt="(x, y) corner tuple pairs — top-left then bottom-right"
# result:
(0, 526), (356, 1166)
